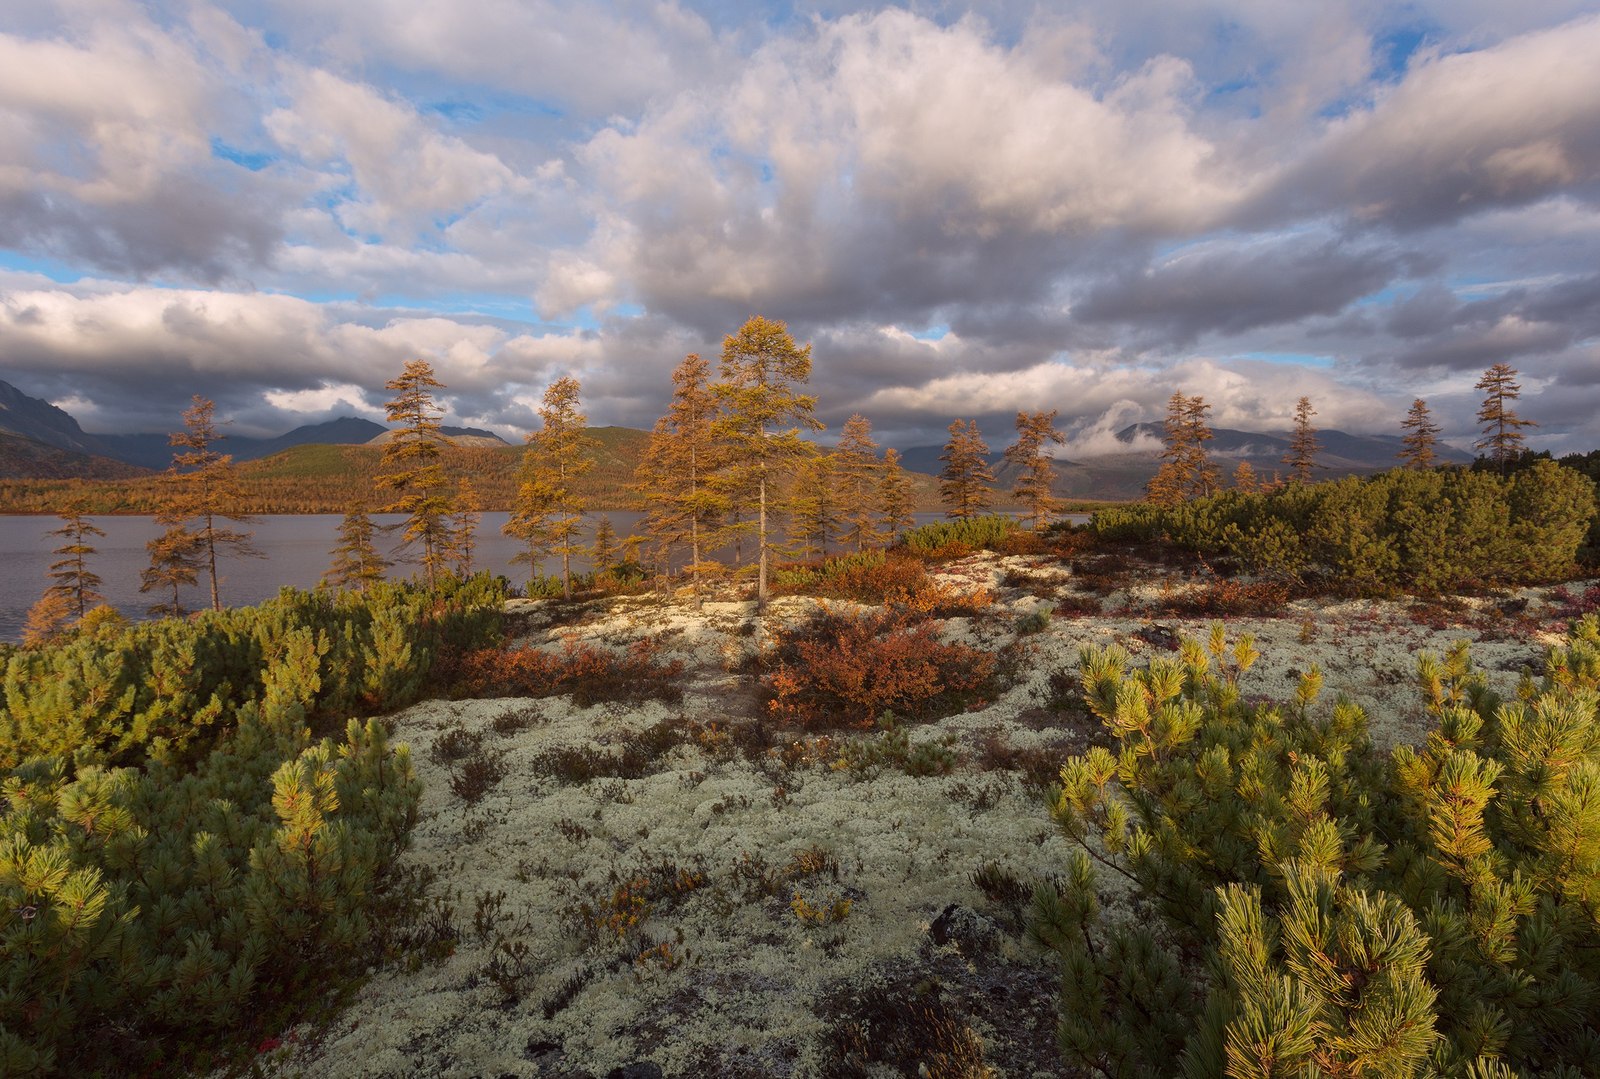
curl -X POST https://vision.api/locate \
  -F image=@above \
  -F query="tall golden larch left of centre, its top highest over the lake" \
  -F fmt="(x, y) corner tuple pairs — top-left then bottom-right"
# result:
(378, 359), (453, 588)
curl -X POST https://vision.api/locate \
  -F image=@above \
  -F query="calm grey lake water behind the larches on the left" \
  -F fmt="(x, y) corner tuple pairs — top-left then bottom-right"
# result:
(0, 511), (1088, 642)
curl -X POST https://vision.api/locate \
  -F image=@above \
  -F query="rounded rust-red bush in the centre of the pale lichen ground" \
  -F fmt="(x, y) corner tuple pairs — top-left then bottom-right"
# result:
(768, 610), (997, 728)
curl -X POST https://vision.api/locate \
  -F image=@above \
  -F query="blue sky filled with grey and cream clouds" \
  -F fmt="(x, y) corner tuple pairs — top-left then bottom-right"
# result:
(0, 0), (1600, 456)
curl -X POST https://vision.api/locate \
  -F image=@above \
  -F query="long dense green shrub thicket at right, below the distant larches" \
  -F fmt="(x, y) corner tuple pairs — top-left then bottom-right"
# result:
(1093, 461), (1595, 592)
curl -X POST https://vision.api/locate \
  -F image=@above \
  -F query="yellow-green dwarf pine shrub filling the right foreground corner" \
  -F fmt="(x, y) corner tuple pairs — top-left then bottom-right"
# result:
(1032, 618), (1600, 1079)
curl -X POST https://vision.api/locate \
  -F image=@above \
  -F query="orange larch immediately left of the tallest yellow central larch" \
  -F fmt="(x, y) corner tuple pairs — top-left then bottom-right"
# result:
(634, 352), (728, 607)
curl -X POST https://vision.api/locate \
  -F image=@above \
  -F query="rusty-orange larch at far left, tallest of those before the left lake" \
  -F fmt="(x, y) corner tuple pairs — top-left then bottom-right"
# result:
(155, 394), (262, 610)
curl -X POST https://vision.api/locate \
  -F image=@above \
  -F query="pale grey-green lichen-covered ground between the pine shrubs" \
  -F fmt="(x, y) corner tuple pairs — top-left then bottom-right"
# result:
(261, 554), (1593, 1077)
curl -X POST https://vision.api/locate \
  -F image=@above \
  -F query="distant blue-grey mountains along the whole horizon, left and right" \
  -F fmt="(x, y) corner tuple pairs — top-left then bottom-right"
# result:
(0, 381), (1472, 499)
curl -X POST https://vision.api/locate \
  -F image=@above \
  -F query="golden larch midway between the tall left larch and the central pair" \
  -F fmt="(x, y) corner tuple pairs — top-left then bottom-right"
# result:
(504, 376), (595, 599)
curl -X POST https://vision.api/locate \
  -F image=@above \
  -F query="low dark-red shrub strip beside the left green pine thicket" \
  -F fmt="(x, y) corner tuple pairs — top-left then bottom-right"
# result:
(448, 640), (683, 708)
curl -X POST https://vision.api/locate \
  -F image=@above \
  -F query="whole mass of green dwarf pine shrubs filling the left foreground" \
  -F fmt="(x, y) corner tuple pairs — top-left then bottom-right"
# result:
(0, 578), (499, 1076)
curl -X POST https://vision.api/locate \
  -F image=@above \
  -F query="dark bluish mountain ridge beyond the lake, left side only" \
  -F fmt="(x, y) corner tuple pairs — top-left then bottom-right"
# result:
(0, 381), (509, 467)
